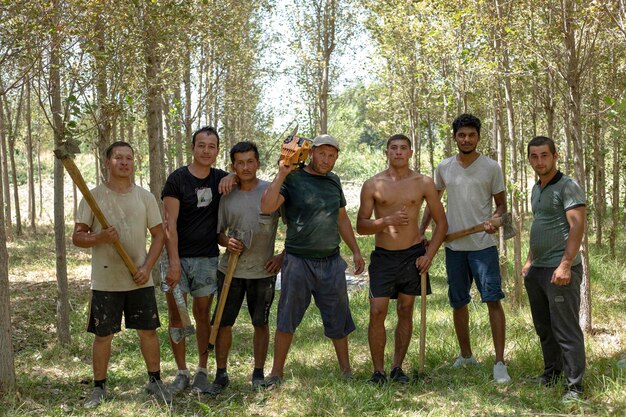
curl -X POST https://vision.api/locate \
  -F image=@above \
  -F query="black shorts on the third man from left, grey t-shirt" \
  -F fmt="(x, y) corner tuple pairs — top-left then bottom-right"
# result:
(211, 270), (276, 327)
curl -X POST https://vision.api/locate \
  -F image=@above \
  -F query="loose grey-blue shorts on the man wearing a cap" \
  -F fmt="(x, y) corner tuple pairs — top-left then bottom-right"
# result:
(276, 252), (355, 339)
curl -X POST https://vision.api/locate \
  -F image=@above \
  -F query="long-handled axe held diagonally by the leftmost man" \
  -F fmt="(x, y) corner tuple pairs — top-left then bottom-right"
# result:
(54, 139), (137, 276)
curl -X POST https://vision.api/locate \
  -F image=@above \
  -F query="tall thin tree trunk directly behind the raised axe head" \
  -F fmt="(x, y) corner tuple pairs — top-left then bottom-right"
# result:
(50, 0), (71, 346)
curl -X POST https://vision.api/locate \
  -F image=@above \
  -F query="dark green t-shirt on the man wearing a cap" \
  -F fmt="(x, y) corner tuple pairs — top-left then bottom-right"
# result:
(280, 169), (346, 258)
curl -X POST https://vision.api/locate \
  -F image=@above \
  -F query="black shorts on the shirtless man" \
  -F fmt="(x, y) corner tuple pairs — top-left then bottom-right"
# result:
(368, 242), (431, 298)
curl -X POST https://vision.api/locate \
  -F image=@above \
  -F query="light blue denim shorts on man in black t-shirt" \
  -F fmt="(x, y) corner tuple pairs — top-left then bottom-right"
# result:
(178, 256), (217, 298)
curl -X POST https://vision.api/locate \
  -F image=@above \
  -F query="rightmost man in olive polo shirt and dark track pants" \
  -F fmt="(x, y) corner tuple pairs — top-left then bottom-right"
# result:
(522, 136), (585, 401)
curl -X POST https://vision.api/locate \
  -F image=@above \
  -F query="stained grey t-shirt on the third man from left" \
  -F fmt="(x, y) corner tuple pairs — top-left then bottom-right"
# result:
(217, 180), (280, 279)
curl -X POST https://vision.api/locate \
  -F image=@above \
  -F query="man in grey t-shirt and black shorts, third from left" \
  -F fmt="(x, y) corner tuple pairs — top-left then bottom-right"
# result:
(211, 142), (282, 394)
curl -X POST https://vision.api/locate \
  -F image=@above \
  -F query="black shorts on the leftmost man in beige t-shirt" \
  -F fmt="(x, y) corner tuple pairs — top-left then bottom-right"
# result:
(87, 287), (161, 337)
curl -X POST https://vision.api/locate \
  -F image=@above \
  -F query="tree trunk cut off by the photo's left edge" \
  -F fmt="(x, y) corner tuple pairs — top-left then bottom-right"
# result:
(0, 137), (16, 396)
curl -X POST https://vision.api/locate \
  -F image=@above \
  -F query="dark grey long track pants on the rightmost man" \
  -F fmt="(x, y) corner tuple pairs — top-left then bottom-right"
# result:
(524, 264), (585, 392)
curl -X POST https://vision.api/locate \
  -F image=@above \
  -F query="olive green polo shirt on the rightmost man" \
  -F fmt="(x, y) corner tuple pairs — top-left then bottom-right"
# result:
(530, 171), (585, 267)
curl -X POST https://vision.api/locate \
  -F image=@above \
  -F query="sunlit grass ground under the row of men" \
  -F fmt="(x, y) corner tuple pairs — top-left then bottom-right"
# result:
(0, 224), (626, 417)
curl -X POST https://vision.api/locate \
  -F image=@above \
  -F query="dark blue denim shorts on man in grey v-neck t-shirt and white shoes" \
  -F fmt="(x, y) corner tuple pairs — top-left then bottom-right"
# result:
(446, 246), (504, 308)
